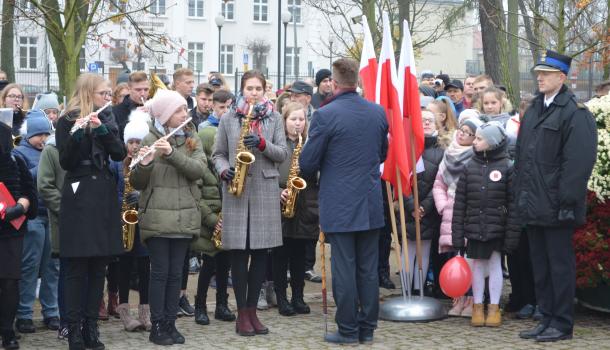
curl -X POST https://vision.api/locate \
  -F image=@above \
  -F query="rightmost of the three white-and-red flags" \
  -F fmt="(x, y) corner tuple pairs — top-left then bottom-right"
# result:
(398, 21), (425, 173)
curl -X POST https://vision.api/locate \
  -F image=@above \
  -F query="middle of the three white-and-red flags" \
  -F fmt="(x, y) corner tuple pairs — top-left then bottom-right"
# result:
(375, 12), (411, 195)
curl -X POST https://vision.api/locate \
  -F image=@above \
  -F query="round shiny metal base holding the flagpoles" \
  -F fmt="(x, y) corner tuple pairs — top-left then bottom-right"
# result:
(379, 296), (447, 322)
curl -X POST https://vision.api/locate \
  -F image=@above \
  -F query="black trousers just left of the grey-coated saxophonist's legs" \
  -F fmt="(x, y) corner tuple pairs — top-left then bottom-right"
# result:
(196, 251), (231, 305)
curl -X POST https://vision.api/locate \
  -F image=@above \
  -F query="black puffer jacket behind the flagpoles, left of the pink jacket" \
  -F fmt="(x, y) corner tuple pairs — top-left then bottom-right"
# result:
(405, 136), (445, 241)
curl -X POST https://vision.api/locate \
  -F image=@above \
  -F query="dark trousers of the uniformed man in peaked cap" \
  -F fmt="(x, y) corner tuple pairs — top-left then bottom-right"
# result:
(527, 226), (576, 332)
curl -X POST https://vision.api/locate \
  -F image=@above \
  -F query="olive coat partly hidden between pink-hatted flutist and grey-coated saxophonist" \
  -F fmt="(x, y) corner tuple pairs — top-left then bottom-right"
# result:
(191, 125), (222, 256)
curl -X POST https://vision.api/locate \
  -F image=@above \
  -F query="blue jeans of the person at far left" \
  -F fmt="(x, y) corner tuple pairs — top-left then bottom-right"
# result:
(17, 216), (59, 320)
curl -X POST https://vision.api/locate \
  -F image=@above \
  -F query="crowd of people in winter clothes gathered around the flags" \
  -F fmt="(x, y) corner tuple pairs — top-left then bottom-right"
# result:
(0, 47), (610, 349)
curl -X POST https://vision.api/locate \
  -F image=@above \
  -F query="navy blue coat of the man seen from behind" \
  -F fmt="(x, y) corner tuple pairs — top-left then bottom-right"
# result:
(299, 90), (388, 233)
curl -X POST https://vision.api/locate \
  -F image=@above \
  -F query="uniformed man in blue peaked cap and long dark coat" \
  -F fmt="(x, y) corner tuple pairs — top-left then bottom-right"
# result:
(515, 51), (597, 342)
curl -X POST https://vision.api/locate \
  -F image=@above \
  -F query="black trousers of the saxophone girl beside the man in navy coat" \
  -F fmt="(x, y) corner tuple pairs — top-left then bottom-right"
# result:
(272, 237), (309, 298)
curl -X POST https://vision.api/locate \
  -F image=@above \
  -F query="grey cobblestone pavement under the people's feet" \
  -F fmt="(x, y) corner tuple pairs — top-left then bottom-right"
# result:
(21, 247), (610, 350)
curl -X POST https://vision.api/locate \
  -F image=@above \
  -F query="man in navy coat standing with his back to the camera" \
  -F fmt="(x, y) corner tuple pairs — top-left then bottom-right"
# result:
(300, 59), (388, 343)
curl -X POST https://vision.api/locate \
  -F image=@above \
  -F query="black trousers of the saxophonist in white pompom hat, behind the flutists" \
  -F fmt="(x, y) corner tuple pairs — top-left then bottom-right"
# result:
(119, 254), (150, 305)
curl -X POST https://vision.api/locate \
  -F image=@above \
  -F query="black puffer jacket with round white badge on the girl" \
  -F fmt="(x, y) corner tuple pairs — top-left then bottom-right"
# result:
(452, 140), (520, 252)
